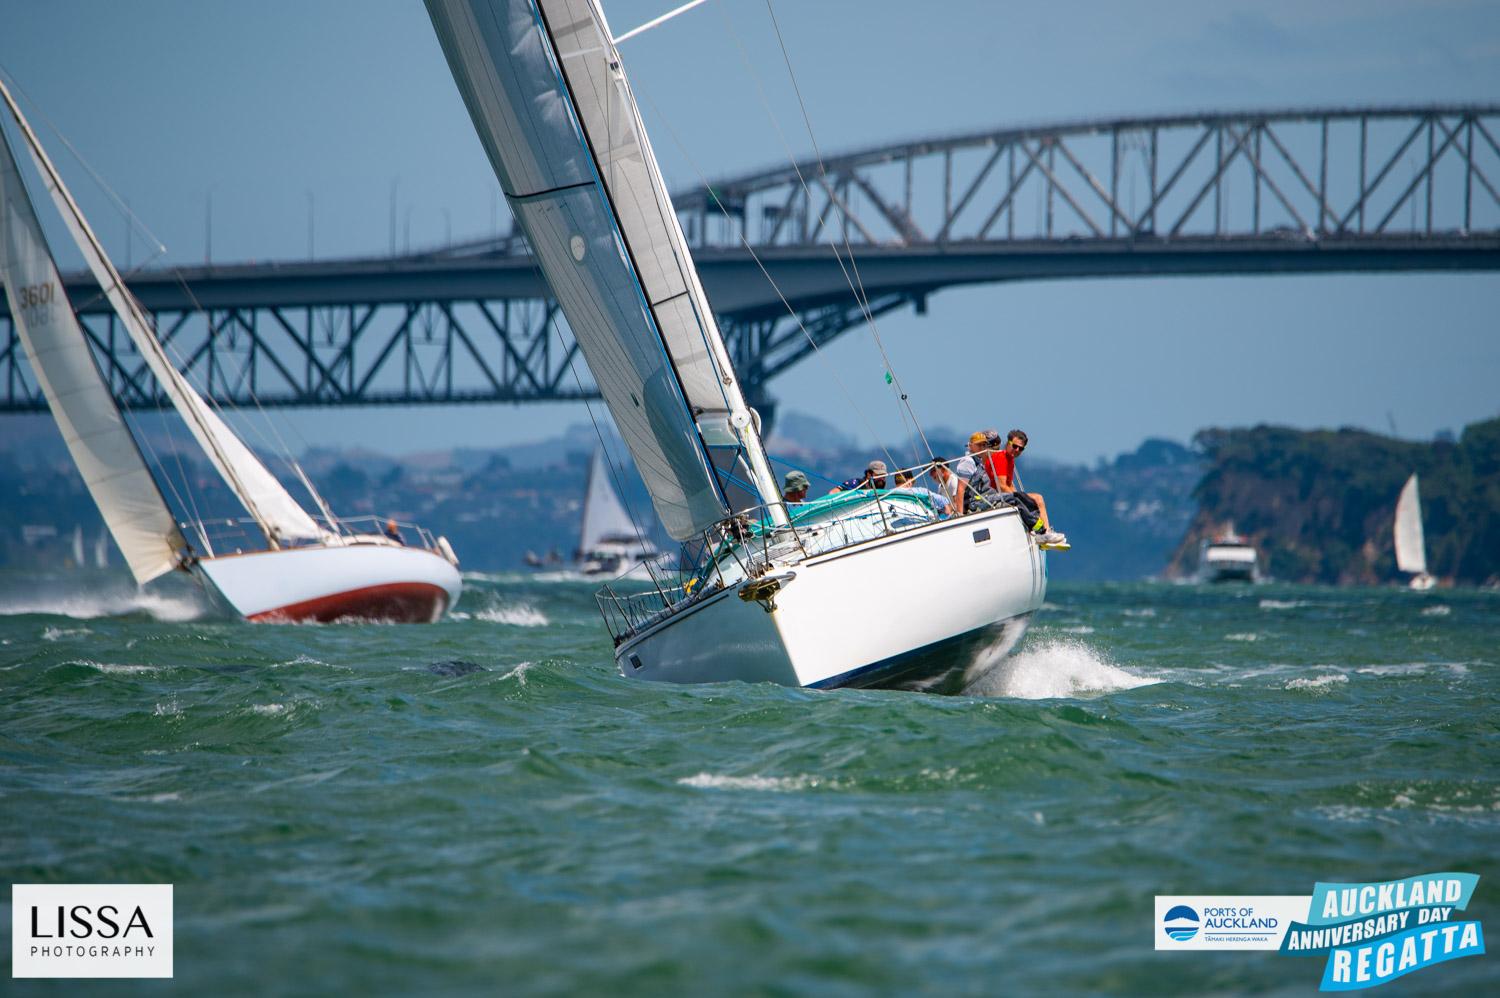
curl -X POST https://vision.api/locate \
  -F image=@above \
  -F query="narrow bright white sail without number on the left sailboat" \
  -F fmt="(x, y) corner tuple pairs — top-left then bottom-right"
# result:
(5, 82), (327, 542)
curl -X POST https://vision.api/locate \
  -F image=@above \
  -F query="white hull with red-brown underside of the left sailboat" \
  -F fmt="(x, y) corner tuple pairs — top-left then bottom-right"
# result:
(195, 543), (464, 623)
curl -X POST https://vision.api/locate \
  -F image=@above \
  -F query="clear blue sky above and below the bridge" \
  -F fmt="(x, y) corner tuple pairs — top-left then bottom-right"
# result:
(0, 0), (1500, 461)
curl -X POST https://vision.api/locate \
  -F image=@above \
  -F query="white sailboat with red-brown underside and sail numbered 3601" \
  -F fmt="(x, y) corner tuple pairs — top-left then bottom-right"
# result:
(0, 81), (462, 621)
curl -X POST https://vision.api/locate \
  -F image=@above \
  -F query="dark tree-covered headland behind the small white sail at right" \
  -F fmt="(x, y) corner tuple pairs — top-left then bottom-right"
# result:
(1172, 419), (1500, 585)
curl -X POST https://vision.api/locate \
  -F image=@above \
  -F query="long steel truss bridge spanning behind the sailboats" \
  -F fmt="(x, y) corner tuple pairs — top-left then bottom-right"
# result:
(0, 105), (1500, 413)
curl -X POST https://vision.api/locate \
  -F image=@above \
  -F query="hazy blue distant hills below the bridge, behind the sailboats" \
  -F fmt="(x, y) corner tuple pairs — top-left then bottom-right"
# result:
(0, 413), (1202, 579)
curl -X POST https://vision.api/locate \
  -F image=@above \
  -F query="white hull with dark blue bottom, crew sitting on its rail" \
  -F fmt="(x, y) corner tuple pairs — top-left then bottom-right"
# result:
(615, 510), (1047, 693)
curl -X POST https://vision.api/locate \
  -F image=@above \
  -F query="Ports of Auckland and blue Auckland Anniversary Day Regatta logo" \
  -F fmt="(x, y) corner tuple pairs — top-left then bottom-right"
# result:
(1155, 873), (1485, 990)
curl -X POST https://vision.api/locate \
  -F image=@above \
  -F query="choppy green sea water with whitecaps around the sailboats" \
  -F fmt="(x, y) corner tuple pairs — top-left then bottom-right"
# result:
(0, 573), (1500, 995)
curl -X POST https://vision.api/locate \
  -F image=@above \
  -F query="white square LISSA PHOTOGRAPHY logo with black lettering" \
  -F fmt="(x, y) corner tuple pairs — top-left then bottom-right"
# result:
(11, 884), (173, 977)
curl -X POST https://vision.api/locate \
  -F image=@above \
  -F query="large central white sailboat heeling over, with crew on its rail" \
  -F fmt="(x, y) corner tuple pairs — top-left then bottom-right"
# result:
(428, 0), (1046, 690)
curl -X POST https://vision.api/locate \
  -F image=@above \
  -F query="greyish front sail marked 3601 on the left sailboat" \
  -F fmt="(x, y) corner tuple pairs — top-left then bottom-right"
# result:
(0, 104), (186, 582)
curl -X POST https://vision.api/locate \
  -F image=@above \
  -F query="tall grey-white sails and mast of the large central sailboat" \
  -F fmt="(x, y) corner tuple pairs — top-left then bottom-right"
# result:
(428, 0), (777, 540)
